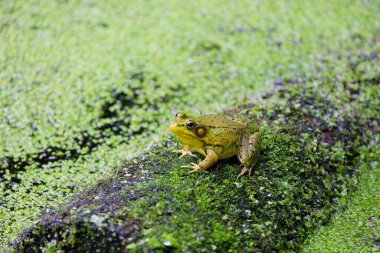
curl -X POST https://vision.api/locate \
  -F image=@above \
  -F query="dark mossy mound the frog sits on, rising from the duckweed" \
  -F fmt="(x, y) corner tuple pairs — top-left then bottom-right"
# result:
(10, 79), (379, 252)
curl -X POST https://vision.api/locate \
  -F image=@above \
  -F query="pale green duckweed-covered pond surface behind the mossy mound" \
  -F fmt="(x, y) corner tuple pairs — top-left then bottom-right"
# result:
(0, 0), (380, 249)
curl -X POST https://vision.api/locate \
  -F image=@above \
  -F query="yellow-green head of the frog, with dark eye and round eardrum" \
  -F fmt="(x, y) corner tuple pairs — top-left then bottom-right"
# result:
(169, 112), (208, 139)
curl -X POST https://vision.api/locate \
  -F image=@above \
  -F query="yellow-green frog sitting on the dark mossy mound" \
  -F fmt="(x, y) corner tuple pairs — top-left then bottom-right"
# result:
(169, 112), (261, 179)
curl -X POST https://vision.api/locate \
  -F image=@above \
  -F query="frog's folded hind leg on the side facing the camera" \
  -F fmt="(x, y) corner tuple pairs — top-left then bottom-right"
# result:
(237, 132), (260, 178)
